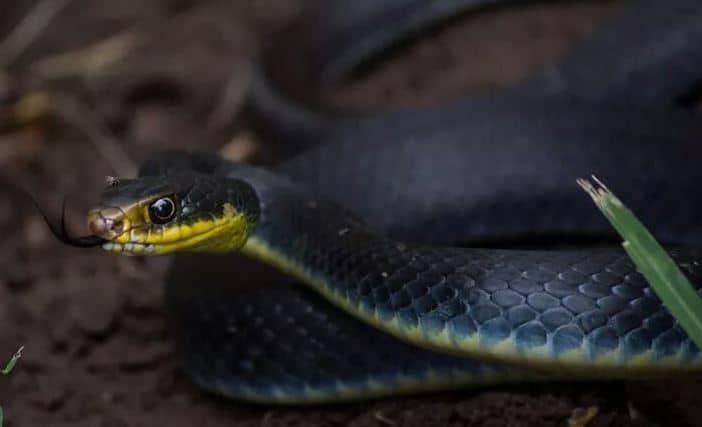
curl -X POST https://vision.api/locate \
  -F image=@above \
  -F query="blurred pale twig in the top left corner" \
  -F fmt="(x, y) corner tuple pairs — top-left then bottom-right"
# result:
(0, 0), (71, 68)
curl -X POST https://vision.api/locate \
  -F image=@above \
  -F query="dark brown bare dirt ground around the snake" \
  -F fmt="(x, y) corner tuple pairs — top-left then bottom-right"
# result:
(0, 0), (702, 427)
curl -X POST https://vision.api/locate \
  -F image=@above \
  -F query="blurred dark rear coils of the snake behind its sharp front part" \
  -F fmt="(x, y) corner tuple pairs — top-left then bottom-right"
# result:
(249, 0), (702, 251)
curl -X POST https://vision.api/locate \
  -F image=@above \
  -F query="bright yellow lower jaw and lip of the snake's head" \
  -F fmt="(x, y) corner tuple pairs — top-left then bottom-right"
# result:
(102, 206), (254, 255)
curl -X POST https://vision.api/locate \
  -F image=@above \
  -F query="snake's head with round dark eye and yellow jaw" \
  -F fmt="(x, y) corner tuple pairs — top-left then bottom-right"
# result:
(87, 171), (260, 255)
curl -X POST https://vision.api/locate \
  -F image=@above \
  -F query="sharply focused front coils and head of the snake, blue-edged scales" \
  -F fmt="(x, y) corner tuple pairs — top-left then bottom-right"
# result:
(95, 153), (702, 403)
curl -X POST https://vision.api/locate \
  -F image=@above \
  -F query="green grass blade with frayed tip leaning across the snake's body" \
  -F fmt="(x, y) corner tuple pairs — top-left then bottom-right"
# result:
(578, 177), (702, 348)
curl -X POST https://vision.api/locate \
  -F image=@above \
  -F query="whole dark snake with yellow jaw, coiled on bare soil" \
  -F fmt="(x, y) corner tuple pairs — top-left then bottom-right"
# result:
(47, 0), (702, 404)
